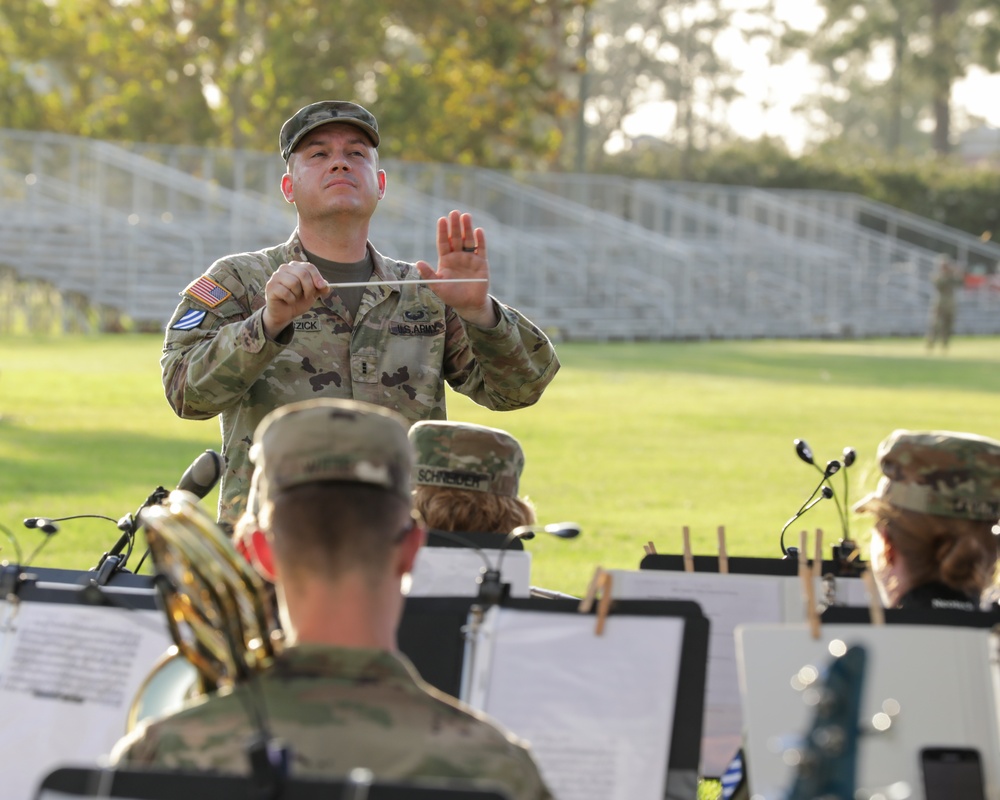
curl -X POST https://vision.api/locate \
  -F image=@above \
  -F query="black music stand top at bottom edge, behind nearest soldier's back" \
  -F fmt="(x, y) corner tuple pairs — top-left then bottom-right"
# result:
(35, 767), (510, 800)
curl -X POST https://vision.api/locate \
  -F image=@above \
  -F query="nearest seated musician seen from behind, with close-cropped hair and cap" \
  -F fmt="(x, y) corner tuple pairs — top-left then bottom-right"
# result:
(112, 399), (564, 800)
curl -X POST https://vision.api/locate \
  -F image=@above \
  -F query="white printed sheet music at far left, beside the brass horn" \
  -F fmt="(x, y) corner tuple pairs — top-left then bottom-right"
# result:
(0, 601), (171, 800)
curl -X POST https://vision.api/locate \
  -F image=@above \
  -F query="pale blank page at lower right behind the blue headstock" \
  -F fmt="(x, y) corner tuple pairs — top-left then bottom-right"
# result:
(737, 624), (1000, 800)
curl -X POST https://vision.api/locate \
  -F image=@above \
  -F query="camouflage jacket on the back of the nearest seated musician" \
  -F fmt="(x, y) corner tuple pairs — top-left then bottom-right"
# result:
(111, 644), (552, 800)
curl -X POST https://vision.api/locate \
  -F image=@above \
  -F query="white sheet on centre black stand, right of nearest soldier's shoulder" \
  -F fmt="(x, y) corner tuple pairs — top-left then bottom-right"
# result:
(465, 606), (684, 800)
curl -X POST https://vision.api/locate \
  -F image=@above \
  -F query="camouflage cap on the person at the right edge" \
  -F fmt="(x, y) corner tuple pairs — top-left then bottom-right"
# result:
(854, 430), (1000, 522)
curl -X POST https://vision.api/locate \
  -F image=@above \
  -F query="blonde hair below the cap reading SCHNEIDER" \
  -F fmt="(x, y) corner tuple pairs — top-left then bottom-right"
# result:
(413, 486), (535, 534)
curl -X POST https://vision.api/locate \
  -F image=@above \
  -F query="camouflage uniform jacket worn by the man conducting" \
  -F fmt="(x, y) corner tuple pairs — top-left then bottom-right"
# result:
(160, 232), (559, 524)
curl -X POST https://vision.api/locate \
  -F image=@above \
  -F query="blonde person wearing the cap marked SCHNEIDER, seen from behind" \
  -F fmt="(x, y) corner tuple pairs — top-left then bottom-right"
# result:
(409, 421), (535, 534)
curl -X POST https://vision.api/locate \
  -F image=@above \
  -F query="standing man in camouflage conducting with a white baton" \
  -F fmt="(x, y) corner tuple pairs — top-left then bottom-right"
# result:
(160, 101), (559, 526)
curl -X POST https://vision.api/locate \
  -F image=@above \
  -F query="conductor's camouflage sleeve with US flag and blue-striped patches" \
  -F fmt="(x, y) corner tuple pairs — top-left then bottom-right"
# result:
(160, 274), (292, 419)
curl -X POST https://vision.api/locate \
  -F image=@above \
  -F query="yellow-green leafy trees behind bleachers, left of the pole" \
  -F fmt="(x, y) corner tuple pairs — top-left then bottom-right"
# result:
(0, 0), (589, 167)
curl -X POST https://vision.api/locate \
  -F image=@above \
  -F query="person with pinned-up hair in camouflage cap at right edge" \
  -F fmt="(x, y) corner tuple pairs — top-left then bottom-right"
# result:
(854, 430), (1000, 611)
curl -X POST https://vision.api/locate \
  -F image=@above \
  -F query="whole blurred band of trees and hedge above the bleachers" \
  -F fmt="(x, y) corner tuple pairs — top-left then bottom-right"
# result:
(0, 0), (1000, 235)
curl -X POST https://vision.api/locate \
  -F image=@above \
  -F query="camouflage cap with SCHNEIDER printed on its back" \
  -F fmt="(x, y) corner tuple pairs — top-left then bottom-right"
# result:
(409, 421), (524, 497)
